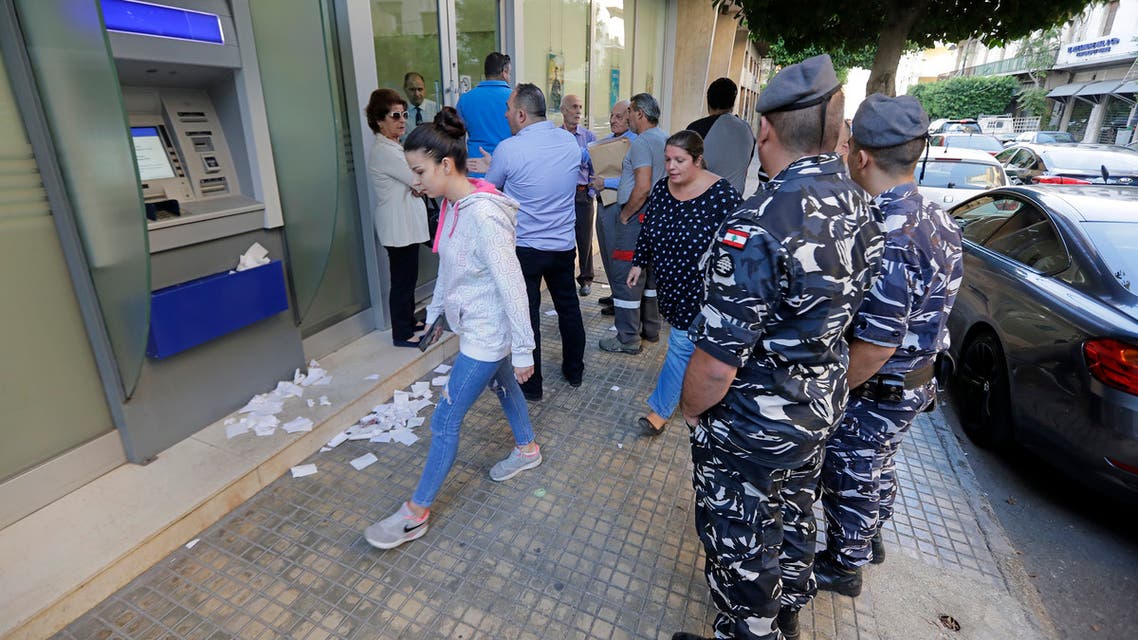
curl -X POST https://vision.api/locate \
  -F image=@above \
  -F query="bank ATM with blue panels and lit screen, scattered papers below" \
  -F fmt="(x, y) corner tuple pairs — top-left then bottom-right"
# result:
(98, 0), (304, 462)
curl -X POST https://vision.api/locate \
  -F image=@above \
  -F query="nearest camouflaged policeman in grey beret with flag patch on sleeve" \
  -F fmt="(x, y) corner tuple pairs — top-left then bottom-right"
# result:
(673, 55), (882, 640)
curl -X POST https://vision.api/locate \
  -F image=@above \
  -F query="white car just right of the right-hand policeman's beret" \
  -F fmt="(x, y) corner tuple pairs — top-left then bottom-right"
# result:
(913, 147), (1007, 203)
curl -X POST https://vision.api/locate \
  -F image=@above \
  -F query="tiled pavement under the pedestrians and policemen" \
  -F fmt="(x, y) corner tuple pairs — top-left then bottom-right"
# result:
(57, 280), (1004, 640)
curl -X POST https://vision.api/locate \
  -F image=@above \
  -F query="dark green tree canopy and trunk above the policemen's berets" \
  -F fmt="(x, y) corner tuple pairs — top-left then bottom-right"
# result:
(728, 0), (1097, 95)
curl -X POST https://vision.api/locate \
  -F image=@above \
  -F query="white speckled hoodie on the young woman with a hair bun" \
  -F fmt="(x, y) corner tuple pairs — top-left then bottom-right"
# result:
(427, 184), (534, 367)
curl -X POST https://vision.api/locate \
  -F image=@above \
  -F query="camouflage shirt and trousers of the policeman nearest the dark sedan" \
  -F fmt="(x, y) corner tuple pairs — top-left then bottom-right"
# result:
(822, 182), (964, 568)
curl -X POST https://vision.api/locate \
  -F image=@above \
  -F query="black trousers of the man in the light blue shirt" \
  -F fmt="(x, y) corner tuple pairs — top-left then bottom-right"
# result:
(518, 247), (585, 395)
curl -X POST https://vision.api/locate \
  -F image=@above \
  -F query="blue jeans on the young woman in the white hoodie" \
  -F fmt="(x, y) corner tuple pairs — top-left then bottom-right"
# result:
(411, 353), (534, 507)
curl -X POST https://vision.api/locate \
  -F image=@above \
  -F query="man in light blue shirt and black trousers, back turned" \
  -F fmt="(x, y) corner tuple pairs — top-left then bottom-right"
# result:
(486, 84), (585, 400)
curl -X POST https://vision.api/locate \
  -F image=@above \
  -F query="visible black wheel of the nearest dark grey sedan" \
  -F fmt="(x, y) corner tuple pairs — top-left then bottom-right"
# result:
(955, 331), (1012, 449)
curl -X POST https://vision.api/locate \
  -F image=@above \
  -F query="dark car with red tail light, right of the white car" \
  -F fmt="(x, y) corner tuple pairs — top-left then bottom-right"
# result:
(996, 145), (1138, 184)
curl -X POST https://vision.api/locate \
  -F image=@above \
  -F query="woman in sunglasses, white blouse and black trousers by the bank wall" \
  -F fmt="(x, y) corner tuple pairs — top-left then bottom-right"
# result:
(364, 89), (430, 346)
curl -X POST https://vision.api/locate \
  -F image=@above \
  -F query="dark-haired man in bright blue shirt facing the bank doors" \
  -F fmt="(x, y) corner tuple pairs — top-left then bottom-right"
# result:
(456, 51), (511, 178)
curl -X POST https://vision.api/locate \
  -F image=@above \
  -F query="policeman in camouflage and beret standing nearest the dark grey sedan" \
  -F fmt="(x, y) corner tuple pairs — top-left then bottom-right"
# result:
(814, 93), (964, 596)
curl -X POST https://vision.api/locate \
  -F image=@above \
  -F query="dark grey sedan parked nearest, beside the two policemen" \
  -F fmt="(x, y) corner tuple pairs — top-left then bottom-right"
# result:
(948, 184), (1138, 498)
